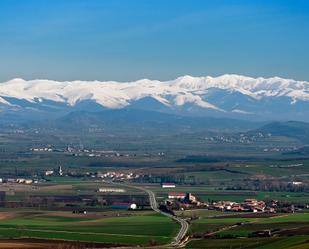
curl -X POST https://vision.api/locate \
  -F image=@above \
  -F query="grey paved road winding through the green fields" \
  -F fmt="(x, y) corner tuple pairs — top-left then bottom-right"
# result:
(110, 182), (189, 247)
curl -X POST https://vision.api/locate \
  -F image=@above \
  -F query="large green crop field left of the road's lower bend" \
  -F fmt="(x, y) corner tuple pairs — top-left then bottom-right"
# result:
(0, 211), (178, 245)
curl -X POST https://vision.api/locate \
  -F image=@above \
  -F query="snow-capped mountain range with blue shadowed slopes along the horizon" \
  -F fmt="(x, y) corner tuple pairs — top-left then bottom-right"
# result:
(0, 74), (309, 120)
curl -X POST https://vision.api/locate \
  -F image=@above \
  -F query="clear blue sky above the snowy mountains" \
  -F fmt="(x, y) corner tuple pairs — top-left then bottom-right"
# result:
(0, 0), (309, 81)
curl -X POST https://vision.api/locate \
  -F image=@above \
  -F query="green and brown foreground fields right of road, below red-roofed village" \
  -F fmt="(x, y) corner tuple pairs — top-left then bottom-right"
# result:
(185, 210), (309, 249)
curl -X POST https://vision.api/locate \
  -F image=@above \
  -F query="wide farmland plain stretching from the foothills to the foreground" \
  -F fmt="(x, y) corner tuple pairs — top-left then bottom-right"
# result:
(0, 122), (309, 249)
